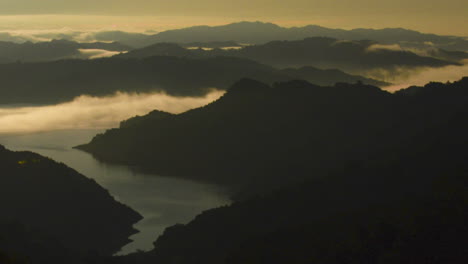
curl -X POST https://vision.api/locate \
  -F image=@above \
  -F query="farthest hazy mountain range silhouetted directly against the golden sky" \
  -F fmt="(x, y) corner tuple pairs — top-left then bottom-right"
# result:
(88, 22), (468, 51)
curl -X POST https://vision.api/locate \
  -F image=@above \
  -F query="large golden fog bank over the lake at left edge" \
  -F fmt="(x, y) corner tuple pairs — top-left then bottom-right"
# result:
(0, 89), (224, 133)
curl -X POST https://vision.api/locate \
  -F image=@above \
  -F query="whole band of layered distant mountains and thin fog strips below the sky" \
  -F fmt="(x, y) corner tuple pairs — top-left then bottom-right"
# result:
(0, 22), (468, 75)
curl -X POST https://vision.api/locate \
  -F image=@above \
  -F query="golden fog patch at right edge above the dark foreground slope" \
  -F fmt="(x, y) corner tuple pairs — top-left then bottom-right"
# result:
(383, 60), (468, 91)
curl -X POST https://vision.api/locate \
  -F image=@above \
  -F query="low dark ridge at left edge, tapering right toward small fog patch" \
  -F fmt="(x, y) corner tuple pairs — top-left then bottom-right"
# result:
(0, 40), (131, 63)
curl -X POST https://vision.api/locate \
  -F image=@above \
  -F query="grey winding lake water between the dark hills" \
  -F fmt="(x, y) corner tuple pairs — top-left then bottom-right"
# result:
(0, 130), (229, 254)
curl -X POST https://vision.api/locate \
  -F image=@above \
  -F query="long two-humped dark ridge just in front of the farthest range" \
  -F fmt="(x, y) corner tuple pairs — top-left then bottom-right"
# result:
(117, 37), (458, 74)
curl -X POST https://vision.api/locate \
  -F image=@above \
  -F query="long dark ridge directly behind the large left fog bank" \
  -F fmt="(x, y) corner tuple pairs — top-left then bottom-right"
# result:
(0, 55), (386, 104)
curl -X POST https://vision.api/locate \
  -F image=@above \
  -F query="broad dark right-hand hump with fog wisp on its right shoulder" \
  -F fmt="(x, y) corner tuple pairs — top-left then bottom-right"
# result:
(215, 37), (456, 73)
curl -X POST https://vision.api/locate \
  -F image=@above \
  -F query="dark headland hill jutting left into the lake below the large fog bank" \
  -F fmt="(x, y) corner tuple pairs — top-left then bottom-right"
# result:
(80, 80), (391, 188)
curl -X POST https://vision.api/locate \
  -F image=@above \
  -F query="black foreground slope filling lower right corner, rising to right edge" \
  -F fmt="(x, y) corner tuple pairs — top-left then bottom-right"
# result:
(92, 78), (468, 264)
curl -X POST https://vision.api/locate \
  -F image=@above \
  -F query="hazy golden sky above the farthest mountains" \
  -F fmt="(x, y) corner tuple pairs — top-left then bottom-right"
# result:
(0, 0), (468, 36)
